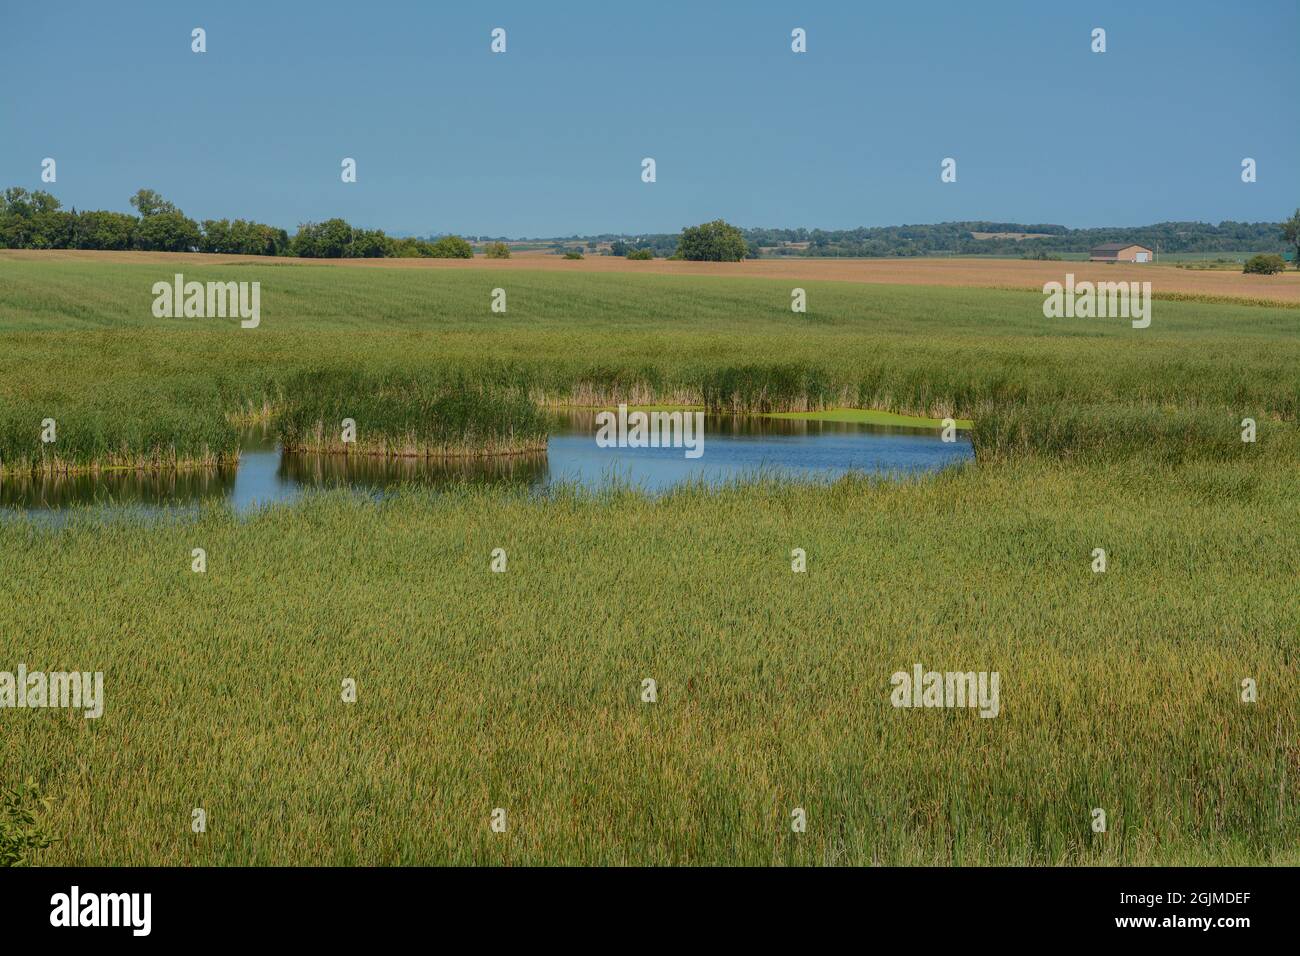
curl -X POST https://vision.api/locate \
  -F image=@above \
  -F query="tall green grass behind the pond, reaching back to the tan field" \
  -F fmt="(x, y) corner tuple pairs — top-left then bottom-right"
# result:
(0, 260), (1300, 467)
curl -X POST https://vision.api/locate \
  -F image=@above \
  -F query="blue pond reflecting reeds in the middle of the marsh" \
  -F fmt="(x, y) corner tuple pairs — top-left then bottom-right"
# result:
(0, 410), (972, 512)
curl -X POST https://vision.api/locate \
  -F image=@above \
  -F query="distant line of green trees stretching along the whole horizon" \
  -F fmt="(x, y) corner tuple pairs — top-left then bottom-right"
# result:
(0, 187), (1300, 261)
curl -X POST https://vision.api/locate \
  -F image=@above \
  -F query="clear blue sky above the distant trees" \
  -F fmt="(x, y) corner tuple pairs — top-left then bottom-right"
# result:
(0, 0), (1300, 237)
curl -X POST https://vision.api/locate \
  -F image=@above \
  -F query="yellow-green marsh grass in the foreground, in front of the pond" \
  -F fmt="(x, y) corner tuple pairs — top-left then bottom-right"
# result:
(0, 460), (1300, 864)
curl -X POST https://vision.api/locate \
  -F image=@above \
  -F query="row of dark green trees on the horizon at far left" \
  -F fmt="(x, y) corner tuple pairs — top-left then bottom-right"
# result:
(0, 187), (473, 259)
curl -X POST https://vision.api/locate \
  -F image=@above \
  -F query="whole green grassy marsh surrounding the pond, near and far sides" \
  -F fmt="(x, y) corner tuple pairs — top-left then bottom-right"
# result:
(0, 261), (1300, 865)
